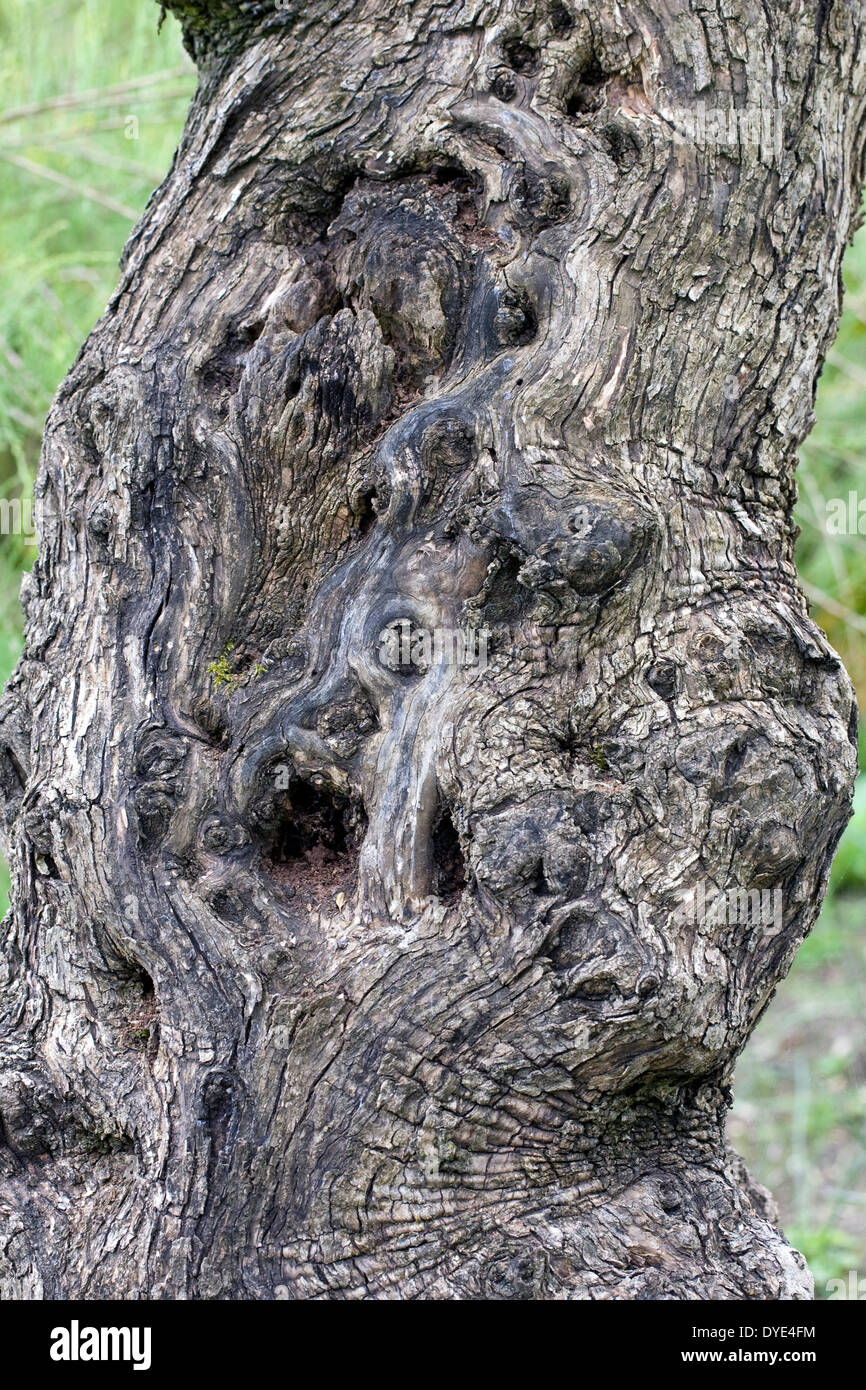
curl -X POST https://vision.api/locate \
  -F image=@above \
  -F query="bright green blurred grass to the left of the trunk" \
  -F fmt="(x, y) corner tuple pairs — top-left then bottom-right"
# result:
(0, 0), (195, 910)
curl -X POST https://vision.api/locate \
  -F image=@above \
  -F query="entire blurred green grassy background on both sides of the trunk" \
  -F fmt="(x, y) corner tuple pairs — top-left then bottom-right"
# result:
(0, 0), (866, 1297)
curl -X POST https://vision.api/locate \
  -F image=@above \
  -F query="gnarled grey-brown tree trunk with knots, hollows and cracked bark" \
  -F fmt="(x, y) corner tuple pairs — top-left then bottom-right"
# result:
(0, 0), (866, 1300)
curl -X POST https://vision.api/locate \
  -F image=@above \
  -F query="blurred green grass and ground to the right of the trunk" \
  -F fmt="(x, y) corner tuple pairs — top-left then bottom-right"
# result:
(728, 201), (866, 1298)
